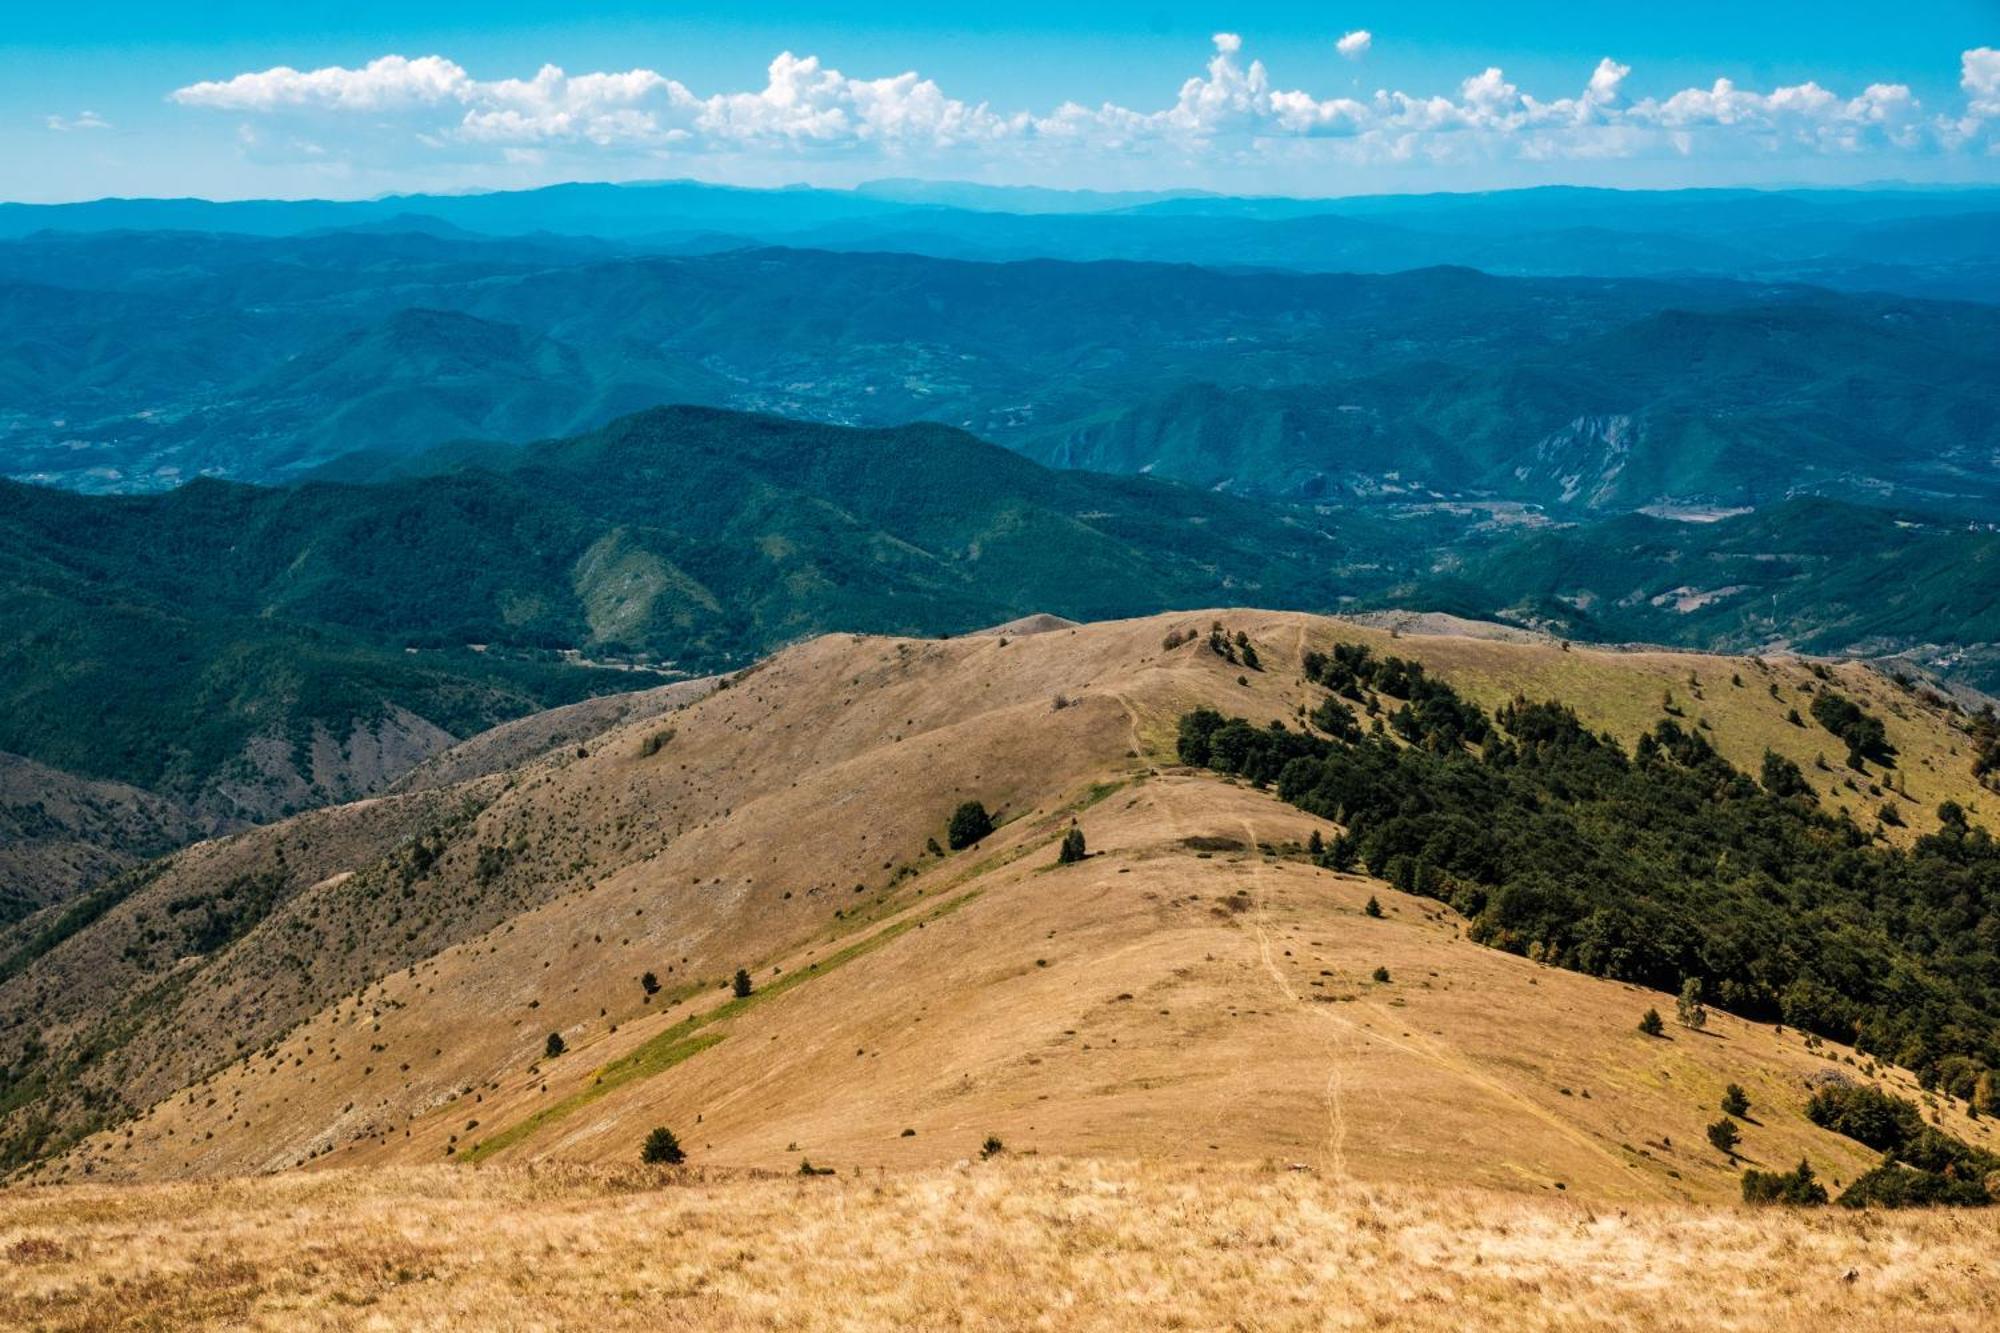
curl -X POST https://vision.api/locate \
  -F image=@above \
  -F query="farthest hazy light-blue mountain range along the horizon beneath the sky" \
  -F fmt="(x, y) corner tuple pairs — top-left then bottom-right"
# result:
(0, 180), (2000, 298)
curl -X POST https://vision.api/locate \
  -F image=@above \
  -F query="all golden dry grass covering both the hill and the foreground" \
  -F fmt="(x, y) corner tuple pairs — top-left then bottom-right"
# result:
(15, 612), (2000, 1329)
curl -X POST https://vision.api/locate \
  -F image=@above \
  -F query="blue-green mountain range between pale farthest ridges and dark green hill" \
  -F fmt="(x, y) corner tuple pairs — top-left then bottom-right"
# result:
(0, 226), (2000, 514)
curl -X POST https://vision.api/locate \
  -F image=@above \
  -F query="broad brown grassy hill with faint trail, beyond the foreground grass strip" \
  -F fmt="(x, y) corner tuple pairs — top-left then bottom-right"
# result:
(0, 610), (1992, 1201)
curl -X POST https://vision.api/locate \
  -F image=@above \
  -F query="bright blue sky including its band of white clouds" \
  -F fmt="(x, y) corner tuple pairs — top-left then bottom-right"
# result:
(11, 0), (2000, 200)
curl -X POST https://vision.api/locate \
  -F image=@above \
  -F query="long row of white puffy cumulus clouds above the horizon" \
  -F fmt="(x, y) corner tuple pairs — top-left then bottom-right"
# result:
(164, 30), (2000, 162)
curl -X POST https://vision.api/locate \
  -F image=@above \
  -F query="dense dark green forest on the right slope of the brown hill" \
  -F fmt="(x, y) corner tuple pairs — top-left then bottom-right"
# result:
(1180, 644), (2000, 1111)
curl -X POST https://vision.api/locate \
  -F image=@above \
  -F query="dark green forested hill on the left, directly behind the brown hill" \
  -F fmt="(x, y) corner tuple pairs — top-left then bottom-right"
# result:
(0, 408), (1388, 819)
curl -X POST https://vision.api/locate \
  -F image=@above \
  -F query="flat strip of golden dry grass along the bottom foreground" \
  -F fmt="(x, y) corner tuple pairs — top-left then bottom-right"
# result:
(0, 1157), (2000, 1329)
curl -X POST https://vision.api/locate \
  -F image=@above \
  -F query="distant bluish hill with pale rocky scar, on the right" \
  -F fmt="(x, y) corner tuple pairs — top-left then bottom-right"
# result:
(1018, 298), (2000, 516)
